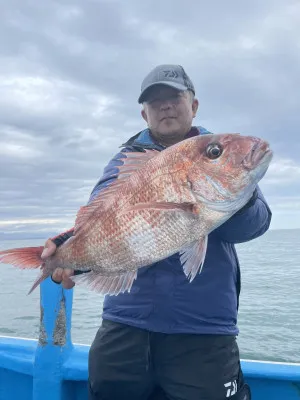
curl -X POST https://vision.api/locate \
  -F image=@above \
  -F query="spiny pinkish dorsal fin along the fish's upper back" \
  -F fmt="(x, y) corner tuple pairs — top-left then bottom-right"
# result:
(74, 150), (160, 235)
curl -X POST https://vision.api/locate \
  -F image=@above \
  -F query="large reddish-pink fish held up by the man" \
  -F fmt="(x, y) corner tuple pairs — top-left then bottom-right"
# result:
(0, 134), (272, 295)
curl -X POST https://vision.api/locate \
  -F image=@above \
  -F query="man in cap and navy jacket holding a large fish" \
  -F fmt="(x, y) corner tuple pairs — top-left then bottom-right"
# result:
(44, 65), (271, 400)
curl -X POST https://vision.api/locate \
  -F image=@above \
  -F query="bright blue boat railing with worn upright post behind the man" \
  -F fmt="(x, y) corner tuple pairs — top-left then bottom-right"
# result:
(0, 278), (300, 400)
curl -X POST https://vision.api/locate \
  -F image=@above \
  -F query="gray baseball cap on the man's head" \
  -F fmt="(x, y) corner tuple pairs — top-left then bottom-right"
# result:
(138, 64), (195, 103)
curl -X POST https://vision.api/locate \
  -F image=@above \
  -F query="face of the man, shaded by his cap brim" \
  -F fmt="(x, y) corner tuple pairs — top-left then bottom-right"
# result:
(142, 85), (198, 142)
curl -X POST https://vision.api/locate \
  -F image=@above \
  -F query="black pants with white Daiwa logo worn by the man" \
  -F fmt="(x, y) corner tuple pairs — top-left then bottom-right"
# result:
(88, 320), (250, 400)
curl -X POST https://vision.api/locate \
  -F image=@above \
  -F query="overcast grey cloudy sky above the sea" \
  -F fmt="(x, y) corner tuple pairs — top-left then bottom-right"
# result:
(0, 0), (300, 237)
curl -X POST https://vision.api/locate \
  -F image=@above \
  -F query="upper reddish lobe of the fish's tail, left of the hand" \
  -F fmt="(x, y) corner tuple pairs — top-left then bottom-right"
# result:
(0, 246), (44, 269)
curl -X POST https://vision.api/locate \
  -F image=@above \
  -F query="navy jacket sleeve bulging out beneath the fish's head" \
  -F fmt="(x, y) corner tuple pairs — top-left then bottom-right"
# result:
(215, 186), (272, 243)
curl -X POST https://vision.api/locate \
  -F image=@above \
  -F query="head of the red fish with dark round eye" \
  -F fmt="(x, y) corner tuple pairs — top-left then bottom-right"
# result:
(187, 134), (273, 213)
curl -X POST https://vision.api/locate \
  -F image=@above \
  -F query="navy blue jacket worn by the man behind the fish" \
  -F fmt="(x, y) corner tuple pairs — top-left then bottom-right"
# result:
(59, 127), (271, 335)
